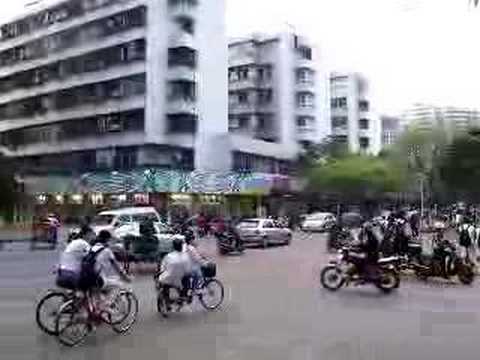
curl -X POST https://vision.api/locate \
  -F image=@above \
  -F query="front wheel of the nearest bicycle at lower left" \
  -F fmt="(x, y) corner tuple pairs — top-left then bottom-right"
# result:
(109, 291), (138, 334)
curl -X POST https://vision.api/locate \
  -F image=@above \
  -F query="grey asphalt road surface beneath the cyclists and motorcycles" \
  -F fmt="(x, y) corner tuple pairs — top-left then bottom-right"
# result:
(0, 231), (480, 360)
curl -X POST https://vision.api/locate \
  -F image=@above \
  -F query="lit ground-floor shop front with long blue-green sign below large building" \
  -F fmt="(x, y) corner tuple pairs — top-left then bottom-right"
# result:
(25, 169), (296, 221)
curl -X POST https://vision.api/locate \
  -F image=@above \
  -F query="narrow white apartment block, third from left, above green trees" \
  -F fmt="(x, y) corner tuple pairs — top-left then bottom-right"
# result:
(330, 73), (381, 155)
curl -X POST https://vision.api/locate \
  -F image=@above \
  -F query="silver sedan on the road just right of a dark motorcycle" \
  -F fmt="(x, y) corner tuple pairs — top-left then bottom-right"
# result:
(237, 219), (292, 248)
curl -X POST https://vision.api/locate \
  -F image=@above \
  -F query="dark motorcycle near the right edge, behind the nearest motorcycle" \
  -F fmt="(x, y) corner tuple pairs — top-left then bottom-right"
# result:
(410, 240), (475, 285)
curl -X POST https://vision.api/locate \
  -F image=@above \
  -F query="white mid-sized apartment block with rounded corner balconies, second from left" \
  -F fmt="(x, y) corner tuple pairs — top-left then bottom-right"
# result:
(228, 32), (326, 159)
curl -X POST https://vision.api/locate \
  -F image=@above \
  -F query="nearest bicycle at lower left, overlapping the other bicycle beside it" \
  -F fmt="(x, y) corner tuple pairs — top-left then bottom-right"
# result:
(55, 289), (138, 347)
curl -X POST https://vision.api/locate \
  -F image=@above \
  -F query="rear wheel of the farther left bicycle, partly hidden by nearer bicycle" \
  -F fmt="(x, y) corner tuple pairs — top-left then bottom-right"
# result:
(35, 291), (68, 336)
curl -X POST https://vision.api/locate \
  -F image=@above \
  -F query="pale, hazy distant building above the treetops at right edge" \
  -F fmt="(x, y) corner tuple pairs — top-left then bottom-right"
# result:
(402, 104), (480, 138)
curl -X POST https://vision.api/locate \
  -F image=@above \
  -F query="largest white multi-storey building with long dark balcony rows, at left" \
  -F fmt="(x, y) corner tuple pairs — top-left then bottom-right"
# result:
(0, 0), (232, 173)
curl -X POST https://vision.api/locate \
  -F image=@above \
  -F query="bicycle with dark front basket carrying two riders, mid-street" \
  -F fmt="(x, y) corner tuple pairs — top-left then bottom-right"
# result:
(154, 263), (225, 318)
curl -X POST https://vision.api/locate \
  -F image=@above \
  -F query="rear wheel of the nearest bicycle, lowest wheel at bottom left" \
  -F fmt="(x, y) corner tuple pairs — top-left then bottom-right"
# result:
(55, 300), (92, 347)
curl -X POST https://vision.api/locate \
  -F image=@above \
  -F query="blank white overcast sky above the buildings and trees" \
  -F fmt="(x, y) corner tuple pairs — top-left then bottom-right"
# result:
(1, 0), (480, 112)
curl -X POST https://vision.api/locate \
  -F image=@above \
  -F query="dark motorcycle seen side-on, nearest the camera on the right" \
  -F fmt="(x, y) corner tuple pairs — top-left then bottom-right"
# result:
(320, 247), (400, 294)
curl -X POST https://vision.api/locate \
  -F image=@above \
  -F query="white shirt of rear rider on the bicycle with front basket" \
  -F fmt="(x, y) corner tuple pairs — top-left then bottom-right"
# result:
(158, 251), (191, 288)
